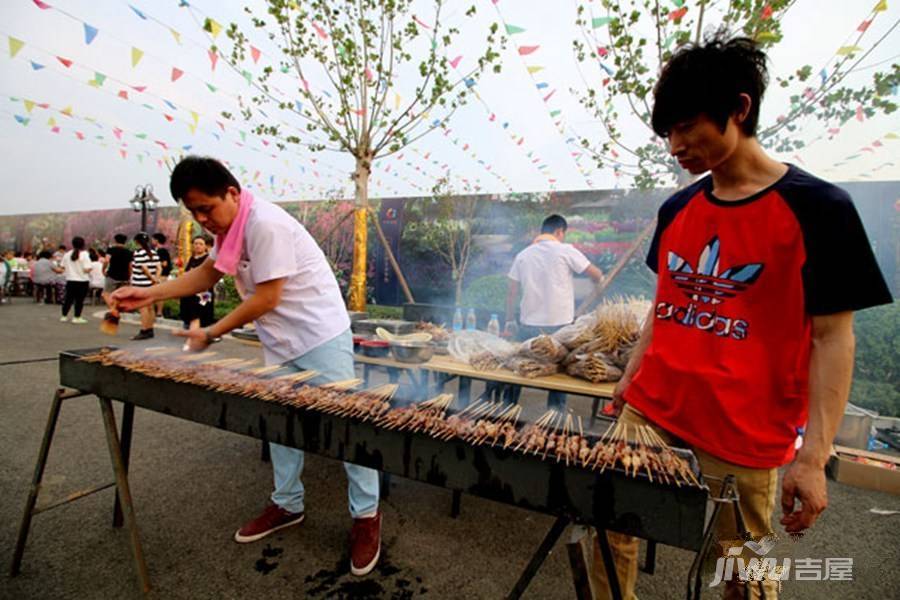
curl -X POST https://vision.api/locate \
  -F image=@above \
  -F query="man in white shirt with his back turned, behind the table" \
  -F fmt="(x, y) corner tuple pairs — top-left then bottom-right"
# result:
(504, 215), (603, 408)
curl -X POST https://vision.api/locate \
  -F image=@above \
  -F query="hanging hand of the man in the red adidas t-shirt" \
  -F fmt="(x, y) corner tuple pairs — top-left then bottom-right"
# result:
(781, 459), (828, 533)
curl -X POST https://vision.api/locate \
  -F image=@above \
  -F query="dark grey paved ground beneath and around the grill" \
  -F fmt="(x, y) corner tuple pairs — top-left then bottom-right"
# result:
(0, 299), (900, 600)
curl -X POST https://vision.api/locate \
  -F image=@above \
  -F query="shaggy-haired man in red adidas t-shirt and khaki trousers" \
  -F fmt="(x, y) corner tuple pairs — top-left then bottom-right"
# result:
(592, 38), (892, 600)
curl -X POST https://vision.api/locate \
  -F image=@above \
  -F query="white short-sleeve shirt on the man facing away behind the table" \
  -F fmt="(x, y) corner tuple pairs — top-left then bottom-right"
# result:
(509, 240), (591, 327)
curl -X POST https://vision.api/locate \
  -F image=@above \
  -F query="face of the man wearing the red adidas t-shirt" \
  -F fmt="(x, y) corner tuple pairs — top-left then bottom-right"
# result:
(668, 114), (740, 175)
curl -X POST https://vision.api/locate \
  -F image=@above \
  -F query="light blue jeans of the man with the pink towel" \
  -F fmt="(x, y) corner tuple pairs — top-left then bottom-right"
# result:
(269, 329), (379, 519)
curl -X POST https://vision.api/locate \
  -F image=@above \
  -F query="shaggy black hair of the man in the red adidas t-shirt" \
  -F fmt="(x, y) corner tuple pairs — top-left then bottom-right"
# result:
(652, 33), (769, 137)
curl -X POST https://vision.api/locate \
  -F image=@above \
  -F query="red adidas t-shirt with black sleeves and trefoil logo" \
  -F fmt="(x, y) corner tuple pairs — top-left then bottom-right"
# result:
(625, 166), (892, 468)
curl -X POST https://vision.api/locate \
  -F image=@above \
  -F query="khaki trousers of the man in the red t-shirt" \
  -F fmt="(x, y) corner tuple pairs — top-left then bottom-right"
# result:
(588, 404), (778, 600)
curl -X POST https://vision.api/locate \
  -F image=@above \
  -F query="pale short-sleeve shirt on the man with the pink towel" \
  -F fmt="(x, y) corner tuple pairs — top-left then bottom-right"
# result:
(210, 198), (350, 364)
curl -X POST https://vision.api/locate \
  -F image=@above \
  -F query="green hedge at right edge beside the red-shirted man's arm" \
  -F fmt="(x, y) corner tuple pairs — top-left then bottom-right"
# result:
(850, 302), (900, 417)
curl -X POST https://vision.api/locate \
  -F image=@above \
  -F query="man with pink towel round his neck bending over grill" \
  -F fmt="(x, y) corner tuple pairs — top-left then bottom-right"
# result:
(112, 156), (381, 575)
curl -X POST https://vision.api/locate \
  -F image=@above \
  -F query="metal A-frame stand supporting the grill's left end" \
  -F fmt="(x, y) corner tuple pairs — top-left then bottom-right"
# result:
(9, 388), (150, 593)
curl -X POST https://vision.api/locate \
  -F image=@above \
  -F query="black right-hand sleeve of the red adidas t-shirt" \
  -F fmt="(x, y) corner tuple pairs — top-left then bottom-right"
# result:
(785, 177), (893, 315)
